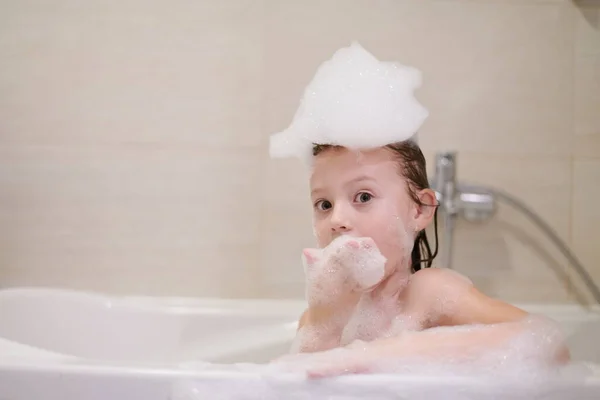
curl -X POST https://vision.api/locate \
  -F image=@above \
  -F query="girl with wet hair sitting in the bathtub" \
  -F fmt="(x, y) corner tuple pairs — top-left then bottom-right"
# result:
(279, 140), (569, 377)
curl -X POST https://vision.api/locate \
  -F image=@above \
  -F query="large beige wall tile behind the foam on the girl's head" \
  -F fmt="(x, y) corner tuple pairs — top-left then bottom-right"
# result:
(265, 1), (574, 155)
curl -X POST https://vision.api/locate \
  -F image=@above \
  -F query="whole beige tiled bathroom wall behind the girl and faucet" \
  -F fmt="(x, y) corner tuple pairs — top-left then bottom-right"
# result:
(0, 0), (600, 302)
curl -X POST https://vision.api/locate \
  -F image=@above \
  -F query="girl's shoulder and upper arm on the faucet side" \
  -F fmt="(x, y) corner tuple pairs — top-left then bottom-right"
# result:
(409, 268), (527, 326)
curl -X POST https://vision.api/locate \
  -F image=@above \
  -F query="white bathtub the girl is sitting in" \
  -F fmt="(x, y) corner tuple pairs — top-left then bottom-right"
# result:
(0, 288), (600, 400)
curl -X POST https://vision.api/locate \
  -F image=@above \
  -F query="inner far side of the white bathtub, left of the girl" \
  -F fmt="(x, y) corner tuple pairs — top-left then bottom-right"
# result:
(0, 289), (302, 363)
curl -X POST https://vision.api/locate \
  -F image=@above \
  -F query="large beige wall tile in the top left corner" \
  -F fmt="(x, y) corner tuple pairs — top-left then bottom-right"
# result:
(0, 0), (264, 145)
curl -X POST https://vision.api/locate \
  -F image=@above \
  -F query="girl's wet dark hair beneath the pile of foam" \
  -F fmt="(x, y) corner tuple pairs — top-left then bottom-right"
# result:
(312, 140), (438, 273)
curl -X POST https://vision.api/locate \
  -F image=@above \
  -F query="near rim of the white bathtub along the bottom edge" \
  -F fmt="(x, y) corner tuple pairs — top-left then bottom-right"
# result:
(0, 363), (600, 400)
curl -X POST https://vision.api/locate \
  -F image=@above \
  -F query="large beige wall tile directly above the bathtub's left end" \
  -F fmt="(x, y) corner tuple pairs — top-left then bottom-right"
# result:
(0, 145), (261, 294)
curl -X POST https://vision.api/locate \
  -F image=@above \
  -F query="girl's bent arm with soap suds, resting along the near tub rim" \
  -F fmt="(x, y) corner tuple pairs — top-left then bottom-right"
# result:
(302, 269), (569, 377)
